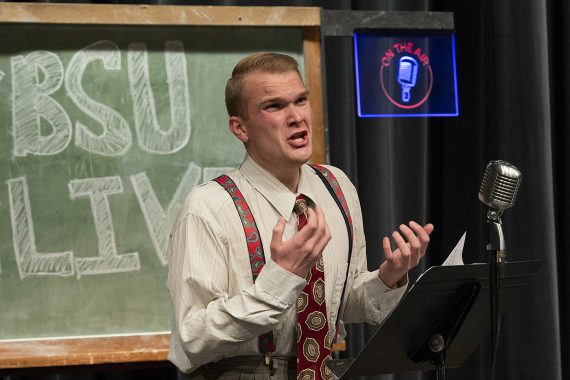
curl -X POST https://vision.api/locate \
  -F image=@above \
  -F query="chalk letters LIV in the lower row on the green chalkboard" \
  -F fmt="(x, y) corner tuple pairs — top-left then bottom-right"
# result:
(0, 162), (232, 279)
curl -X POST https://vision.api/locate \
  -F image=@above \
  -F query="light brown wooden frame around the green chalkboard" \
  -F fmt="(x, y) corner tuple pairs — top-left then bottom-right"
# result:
(0, 3), (326, 369)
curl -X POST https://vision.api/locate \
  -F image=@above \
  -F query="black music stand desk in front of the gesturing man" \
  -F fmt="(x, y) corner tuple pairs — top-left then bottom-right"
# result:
(327, 260), (541, 379)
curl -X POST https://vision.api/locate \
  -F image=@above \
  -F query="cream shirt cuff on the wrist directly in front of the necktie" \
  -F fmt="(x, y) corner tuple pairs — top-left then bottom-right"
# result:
(255, 260), (307, 306)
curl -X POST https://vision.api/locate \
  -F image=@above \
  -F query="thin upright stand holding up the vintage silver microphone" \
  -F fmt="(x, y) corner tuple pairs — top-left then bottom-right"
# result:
(487, 209), (507, 379)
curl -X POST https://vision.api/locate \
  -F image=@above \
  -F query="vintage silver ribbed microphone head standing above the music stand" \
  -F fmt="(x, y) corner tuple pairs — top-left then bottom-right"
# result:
(479, 160), (522, 262)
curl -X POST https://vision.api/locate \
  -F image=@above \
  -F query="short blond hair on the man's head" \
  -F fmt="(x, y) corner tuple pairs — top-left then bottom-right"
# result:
(226, 52), (301, 119)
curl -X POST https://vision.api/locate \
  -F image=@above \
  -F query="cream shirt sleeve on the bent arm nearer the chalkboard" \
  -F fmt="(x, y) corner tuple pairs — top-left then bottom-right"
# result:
(167, 189), (305, 367)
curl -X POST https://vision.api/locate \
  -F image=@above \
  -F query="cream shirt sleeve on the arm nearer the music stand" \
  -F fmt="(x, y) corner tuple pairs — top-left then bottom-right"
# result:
(326, 169), (406, 324)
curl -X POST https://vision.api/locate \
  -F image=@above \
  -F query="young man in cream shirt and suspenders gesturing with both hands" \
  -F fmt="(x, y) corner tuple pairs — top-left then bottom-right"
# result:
(167, 53), (433, 379)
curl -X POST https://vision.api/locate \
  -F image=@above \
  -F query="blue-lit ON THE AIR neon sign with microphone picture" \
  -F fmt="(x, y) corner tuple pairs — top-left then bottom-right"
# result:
(354, 33), (459, 117)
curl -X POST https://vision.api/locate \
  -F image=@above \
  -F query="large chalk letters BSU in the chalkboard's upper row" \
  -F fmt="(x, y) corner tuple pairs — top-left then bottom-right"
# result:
(10, 41), (191, 157)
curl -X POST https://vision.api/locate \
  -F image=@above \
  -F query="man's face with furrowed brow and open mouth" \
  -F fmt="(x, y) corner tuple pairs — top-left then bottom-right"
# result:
(230, 71), (313, 178)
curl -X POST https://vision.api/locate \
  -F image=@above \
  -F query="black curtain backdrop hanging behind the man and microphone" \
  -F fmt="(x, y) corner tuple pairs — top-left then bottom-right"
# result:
(3, 0), (570, 380)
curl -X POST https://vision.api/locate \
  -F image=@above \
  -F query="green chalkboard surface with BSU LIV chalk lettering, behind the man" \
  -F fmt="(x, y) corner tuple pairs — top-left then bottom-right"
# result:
(0, 24), (303, 340)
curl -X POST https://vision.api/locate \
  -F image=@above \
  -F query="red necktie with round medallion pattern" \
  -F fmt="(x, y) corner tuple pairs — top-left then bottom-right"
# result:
(294, 194), (332, 380)
